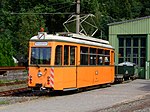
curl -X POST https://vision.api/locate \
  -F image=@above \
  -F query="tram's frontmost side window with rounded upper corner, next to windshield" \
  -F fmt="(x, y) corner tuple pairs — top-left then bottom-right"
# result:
(55, 46), (62, 65)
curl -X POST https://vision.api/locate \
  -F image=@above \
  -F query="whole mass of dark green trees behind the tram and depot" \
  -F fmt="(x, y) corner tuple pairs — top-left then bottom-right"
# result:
(0, 0), (150, 66)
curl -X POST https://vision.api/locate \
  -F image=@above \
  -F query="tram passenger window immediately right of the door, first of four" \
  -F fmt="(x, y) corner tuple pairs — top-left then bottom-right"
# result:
(80, 47), (88, 65)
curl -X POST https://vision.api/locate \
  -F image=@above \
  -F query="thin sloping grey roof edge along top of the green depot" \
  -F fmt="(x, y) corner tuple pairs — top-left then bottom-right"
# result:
(107, 16), (150, 26)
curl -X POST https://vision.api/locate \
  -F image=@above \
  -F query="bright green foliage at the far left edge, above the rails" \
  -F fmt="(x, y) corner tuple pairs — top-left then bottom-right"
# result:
(0, 10), (14, 66)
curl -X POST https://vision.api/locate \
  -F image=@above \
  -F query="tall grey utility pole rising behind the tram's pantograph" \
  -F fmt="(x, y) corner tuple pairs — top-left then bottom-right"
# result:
(76, 0), (80, 34)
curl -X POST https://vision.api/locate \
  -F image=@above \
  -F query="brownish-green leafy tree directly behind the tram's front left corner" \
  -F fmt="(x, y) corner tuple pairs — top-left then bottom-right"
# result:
(13, 11), (45, 61)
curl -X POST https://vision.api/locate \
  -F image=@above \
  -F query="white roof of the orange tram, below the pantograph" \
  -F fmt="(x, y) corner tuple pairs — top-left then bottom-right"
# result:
(30, 32), (113, 48)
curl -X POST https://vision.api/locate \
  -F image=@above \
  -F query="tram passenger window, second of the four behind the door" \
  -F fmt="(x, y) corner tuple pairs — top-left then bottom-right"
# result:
(90, 48), (96, 65)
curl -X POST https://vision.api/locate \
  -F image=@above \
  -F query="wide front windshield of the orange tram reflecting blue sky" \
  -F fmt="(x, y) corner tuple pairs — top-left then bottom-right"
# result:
(30, 47), (51, 65)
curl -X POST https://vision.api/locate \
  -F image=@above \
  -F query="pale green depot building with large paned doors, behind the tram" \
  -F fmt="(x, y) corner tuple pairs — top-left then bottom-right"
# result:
(108, 16), (150, 79)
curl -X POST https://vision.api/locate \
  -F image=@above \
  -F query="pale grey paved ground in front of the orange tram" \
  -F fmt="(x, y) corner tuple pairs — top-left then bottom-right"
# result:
(0, 79), (150, 112)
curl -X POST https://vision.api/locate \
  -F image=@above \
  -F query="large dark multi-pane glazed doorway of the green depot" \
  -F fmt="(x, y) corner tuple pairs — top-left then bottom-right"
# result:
(118, 35), (146, 67)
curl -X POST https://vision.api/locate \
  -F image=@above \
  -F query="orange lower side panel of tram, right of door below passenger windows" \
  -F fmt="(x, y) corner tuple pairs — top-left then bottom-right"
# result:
(77, 66), (114, 88)
